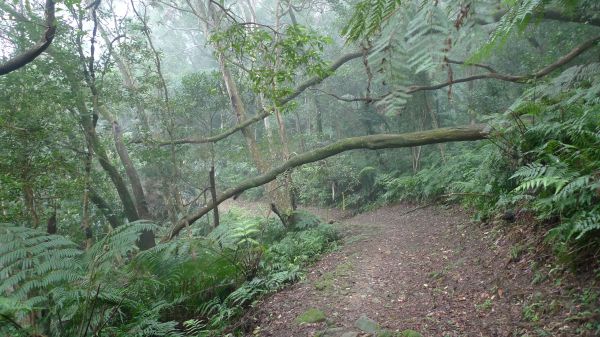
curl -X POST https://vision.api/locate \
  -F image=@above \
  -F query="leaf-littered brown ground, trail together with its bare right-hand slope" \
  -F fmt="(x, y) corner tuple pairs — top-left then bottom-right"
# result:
(225, 204), (600, 337)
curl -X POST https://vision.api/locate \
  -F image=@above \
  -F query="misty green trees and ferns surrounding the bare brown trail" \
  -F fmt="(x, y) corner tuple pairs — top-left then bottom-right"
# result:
(0, 0), (600, 336)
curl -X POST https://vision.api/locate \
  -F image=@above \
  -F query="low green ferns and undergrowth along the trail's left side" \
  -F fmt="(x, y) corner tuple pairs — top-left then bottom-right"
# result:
(0, 212), (337, 337)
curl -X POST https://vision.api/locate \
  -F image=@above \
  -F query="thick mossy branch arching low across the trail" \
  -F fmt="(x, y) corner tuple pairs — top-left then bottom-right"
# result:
(164, 124), (491, 241)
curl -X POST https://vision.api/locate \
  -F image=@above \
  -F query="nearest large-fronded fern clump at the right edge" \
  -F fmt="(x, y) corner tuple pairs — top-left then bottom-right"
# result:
(512, 98), (600, 252)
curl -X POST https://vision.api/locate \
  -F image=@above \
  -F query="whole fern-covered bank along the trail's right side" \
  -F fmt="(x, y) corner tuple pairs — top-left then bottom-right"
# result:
(376, 91), (600, 264)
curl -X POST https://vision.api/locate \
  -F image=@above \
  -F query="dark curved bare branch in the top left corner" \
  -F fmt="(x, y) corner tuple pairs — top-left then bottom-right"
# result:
(0, 0), (56, 75)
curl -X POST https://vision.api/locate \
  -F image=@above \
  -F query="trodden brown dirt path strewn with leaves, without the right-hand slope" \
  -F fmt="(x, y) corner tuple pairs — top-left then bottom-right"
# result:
(241, 205), (568, 337)
